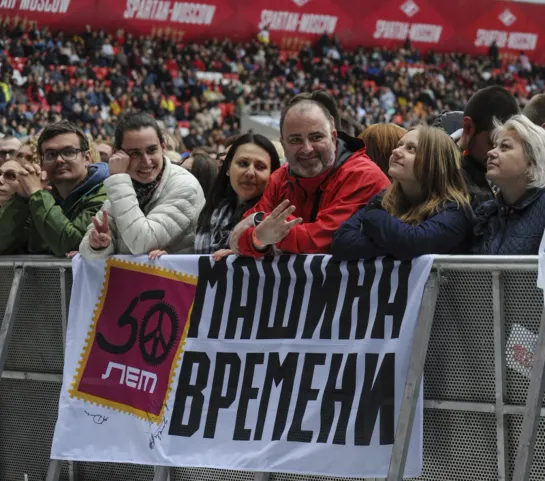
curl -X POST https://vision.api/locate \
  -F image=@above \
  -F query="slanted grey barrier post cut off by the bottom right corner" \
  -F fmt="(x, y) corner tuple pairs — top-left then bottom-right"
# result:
(513, 304), (545, 481)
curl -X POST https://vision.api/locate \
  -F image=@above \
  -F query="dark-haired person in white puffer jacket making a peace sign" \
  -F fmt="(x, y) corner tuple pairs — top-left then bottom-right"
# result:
(80, 113), (205, 259)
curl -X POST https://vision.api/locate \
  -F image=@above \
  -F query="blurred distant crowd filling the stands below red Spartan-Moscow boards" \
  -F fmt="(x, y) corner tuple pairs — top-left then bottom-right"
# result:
(0, 21), (545, 152)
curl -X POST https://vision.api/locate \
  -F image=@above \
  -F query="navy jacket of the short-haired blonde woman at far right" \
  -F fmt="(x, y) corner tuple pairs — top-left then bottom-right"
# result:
(472, 189), (545, 255)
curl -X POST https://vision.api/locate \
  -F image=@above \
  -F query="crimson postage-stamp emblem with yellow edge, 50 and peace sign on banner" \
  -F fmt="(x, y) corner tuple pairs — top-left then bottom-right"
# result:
(70, 258), (197, 426)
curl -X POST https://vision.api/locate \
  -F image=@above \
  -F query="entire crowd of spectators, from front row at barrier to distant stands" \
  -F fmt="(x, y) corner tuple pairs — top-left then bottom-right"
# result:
(0, 24), (545, 260)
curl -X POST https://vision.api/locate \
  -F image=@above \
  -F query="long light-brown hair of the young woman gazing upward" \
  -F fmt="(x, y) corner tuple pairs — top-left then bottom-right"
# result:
(382, 125), (470, 225)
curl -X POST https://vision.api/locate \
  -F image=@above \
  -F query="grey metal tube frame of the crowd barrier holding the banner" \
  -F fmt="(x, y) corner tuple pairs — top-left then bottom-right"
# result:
(0, 256), (545, 481)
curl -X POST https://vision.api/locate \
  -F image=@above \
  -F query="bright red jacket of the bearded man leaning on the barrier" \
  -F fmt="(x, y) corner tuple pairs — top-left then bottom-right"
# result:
(238, 135), (390, 257)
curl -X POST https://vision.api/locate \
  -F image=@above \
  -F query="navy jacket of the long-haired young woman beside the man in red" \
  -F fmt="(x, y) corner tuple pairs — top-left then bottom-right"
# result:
(331, 193), (473, 261)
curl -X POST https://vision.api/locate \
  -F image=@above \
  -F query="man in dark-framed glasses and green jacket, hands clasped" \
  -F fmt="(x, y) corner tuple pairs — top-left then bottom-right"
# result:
(0, 121), (108, 256)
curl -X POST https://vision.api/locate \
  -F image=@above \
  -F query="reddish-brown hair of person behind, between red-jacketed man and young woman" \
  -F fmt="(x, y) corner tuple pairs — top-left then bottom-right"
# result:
(359, 124), (407, 177)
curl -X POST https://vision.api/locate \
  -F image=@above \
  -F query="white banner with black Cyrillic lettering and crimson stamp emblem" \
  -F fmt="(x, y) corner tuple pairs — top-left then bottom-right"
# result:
(52, 256), (433, 478)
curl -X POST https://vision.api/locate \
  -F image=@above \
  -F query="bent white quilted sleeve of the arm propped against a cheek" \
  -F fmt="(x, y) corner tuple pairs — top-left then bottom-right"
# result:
(104, 174), (203, 255)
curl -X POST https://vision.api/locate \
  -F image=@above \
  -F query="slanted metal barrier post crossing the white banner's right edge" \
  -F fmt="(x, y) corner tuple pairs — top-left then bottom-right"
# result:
(387, 271), (441, 481)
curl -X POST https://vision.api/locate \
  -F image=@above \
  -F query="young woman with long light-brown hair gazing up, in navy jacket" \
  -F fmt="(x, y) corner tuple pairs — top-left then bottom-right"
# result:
(331, 126), (473, 260)
